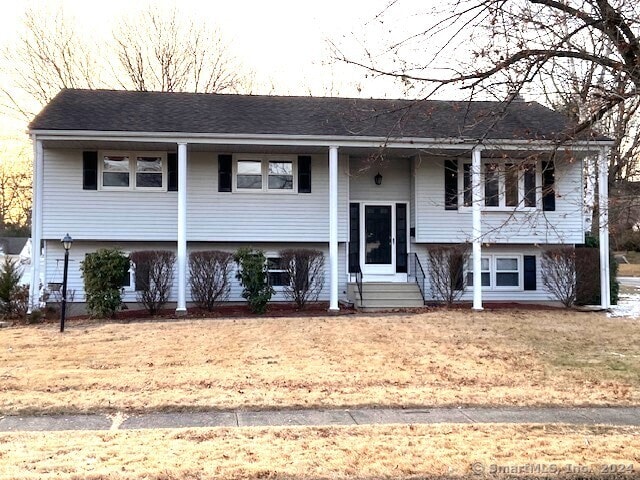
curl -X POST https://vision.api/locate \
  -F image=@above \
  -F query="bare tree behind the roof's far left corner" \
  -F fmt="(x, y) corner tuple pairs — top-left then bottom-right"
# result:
(0, 8), (100, 120)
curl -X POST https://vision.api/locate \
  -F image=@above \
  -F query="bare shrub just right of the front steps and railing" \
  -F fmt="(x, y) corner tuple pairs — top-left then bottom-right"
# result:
(427, 243), (471, 305)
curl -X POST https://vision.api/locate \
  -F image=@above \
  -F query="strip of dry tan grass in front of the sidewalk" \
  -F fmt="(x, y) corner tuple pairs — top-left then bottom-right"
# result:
(0, 425), (640, 480)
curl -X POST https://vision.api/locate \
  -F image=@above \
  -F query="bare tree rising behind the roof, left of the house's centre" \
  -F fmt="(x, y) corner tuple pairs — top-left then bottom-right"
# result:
(114, 6), (242, 93)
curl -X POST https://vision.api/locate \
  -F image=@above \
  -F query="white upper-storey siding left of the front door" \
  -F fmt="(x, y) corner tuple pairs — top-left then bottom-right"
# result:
(43, 149), (349, 242)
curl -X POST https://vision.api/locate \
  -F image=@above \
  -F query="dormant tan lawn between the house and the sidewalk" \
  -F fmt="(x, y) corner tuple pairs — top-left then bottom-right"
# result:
(0, 310), (640, 415)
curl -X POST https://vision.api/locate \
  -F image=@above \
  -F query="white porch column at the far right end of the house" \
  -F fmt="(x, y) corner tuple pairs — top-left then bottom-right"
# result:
(598, 147), (611, 308)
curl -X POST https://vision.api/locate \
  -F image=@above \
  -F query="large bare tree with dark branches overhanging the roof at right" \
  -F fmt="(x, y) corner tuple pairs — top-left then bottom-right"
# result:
(334, 0), (640, 141)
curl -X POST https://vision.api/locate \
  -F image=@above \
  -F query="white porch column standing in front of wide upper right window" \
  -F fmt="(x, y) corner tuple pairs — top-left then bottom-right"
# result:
(471, 147), (482, 310)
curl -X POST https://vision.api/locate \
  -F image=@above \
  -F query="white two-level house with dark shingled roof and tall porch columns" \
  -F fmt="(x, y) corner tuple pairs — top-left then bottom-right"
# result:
(30, 90), (610, 312)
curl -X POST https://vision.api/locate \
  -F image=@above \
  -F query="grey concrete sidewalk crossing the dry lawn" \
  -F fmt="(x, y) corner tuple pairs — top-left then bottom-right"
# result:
(0, 407), (640, 432)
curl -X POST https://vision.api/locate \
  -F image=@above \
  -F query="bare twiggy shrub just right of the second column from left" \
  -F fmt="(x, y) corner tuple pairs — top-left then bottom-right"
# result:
(189, 250), (233, 311)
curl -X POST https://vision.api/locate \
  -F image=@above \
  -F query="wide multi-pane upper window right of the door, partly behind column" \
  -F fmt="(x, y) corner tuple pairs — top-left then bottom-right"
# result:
(459, 162), (540, 209)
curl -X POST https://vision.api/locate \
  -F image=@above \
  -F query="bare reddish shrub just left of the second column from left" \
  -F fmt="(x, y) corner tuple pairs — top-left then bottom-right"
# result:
(130, 250), (176, 315)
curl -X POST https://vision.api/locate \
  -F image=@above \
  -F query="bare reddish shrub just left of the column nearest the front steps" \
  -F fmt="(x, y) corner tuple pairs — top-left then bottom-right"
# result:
(280, 249), (324, 310)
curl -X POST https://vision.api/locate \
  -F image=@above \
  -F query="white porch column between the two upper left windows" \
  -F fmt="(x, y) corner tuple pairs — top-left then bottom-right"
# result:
(176, 143), (187, 314)
